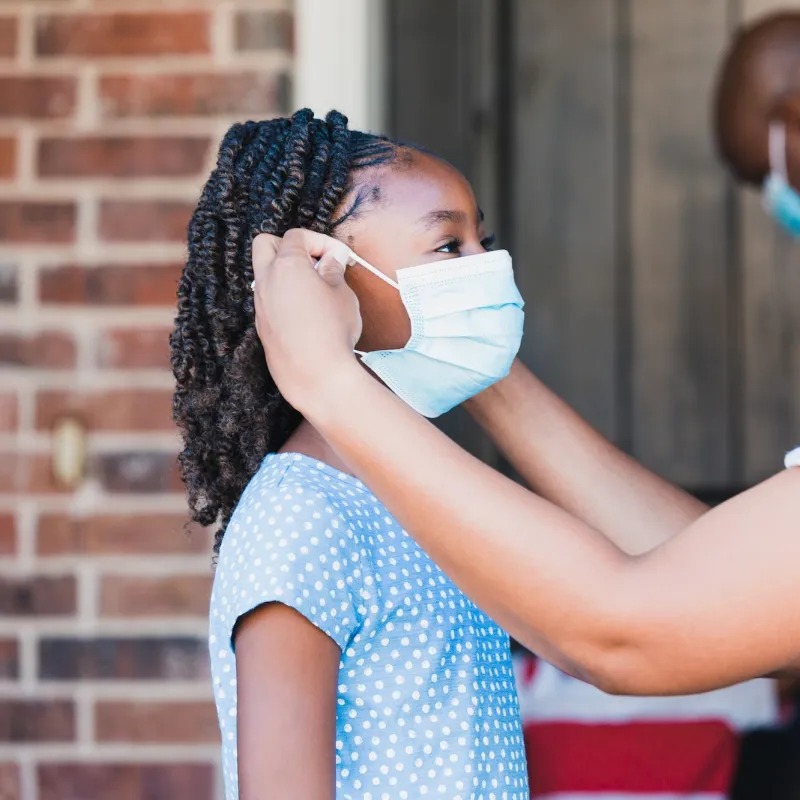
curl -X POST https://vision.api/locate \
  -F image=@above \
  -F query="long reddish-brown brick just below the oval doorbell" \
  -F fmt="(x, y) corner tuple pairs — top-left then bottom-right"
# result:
(36, 514), (212, 556)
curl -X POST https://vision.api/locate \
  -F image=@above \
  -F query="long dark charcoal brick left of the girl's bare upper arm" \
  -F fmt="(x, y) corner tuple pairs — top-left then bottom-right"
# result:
(39, 636), (209, 681)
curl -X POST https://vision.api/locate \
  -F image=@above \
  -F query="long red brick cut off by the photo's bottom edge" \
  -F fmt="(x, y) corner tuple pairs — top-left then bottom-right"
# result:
(38, 763), (216, 800)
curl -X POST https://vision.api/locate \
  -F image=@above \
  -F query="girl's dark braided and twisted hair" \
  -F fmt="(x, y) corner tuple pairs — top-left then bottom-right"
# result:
(170, 109), (416, 552)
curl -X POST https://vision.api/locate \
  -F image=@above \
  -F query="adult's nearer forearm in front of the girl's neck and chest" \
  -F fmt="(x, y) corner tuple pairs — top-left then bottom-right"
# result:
(301, 368), (628, 682)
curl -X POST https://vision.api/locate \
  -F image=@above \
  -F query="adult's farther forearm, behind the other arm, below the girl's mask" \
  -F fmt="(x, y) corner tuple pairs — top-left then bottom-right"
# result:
(466, 361), (708, 555)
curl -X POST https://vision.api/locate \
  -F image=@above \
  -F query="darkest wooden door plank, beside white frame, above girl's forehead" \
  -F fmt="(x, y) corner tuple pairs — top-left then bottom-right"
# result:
(388, 0), (500, 466)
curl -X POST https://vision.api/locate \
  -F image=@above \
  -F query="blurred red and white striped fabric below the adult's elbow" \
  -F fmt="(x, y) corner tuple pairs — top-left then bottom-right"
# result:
(515, 654), (780, 800)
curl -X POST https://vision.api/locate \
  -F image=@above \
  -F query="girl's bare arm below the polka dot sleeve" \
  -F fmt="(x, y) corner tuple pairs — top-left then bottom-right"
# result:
(234, 603), (340, 800)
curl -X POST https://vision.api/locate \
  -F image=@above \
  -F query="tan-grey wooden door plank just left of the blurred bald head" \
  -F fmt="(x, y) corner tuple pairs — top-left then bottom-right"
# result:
(630, 0), (731, 488)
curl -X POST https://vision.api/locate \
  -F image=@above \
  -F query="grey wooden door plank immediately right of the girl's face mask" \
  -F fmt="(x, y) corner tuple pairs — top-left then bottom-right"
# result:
(513, 0), (619, 438)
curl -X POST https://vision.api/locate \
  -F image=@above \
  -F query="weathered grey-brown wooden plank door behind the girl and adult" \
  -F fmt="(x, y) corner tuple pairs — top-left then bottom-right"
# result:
(389, 0), (800, 492)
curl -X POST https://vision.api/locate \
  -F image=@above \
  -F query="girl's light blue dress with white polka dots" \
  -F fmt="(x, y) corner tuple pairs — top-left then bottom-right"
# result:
(209, 454), (529, 800)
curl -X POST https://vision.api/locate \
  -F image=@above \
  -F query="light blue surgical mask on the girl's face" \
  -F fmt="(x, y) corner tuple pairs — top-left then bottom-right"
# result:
(352, 250), (524, 417)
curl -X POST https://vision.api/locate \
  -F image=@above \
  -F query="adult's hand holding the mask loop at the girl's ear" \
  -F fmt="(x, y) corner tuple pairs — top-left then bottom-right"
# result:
(253, 230), (361, 412)
